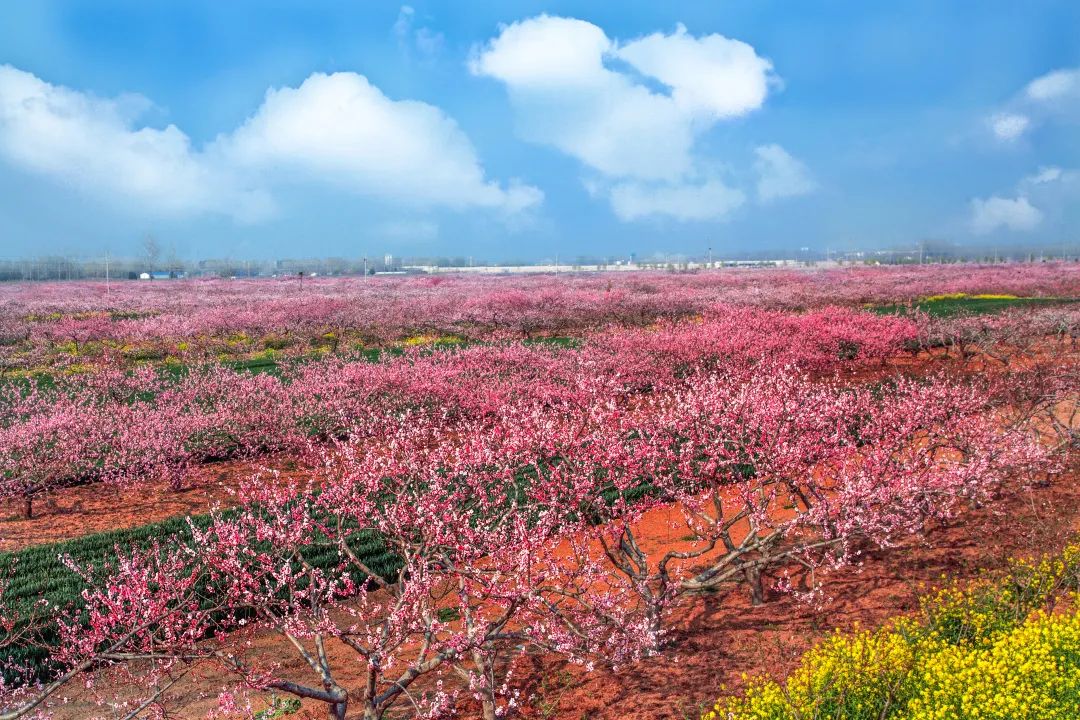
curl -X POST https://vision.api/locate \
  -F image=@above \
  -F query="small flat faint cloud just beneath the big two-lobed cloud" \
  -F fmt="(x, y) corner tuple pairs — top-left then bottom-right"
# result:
(610, 180), (746, 221)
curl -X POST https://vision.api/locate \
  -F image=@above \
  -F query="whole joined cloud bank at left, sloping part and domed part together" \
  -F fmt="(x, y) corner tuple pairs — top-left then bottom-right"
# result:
(0, 66), (542, 221)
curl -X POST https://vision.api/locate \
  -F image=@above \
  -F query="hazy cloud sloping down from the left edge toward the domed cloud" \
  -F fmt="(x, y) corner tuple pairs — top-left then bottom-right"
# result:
(0, 65), (271, 220)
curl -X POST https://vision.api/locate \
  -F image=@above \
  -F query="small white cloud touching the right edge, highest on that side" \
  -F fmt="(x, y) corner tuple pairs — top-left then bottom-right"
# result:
(987, 68), (1080, 142)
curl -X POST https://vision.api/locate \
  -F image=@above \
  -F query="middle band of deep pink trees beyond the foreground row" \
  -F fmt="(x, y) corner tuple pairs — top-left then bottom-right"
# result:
(0, 308), (916, 515)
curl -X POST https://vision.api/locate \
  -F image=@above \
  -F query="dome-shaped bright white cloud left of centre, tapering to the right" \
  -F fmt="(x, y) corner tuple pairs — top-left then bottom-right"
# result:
(214, 72), (542, 212)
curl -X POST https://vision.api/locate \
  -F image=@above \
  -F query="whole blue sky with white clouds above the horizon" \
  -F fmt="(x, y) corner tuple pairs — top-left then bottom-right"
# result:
(0, 0), (1080, 260)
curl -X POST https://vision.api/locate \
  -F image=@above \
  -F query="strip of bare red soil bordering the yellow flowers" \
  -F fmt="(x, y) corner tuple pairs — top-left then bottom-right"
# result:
(517, 470), (1080, 720)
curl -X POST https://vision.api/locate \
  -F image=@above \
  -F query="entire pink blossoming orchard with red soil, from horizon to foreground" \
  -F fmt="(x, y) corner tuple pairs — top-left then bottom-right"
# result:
(0, 262), (1080, 720)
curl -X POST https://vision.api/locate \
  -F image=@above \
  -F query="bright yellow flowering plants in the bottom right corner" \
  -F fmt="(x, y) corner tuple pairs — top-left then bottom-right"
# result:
(705, 544), (1080, 720)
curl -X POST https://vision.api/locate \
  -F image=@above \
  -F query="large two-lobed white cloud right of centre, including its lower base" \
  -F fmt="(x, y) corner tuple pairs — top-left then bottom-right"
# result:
(469, 15), (778, 219)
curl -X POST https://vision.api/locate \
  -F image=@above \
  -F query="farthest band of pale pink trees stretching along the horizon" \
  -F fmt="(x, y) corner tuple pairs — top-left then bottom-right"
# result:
(0, 263), (1080, 369)
